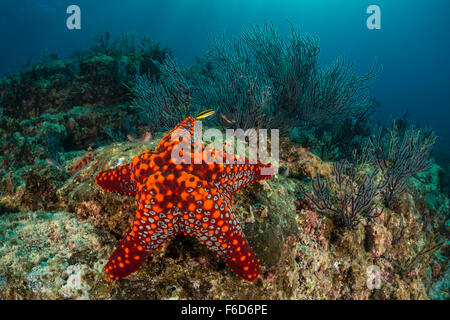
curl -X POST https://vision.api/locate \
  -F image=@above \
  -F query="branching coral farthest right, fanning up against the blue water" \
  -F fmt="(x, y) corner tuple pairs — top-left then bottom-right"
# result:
(371, 122), (436, 207)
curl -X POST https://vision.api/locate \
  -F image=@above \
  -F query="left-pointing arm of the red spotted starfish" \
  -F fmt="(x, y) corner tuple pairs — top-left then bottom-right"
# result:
(95, 164), (137, 195)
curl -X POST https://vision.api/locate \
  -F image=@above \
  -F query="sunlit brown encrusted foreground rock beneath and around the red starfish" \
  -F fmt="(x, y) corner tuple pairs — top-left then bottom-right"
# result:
(0, 135), (450, 299)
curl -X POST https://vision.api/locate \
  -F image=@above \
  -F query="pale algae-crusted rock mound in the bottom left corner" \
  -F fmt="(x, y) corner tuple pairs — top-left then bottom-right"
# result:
(0, 211), (116, 299)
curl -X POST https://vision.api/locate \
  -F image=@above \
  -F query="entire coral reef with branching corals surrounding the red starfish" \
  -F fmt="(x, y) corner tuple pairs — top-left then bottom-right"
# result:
(0, 24), (450, 300)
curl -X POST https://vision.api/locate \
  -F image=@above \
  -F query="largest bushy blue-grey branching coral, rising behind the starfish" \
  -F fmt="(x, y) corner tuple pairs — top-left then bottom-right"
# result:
(196, 23), (379, 131)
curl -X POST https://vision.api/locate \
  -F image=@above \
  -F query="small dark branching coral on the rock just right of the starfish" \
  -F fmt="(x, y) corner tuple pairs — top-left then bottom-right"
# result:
(300, 161), (381, 228)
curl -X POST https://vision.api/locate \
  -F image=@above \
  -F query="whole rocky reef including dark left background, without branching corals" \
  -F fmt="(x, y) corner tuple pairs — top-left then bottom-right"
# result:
(0, 31), (450, 300)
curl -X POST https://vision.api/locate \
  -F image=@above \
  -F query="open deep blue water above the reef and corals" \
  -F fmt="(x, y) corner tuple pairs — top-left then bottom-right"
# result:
(0, 0), (450, 148)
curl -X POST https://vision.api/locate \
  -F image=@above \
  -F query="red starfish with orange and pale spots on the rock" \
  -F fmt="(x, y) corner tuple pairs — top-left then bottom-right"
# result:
(95, 118), (273, 280)
